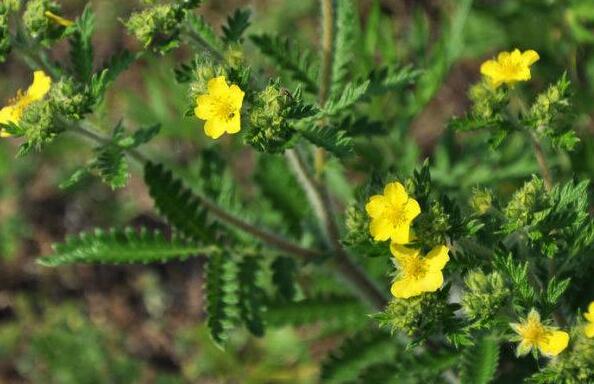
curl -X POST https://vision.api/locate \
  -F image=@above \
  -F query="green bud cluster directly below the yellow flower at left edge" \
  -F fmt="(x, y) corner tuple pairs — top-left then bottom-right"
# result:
(19, 99), (61, 148)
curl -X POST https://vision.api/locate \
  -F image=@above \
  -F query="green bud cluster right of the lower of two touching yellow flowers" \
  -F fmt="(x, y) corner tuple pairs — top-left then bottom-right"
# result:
(462, 270), (510, 327)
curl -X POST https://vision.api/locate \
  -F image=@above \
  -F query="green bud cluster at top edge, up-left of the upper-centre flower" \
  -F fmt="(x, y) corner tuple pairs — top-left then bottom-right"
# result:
(125, 4), (184, 53)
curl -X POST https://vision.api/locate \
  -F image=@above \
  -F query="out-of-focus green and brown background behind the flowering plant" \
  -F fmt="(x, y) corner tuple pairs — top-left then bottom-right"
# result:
(0, 0), (594, 384)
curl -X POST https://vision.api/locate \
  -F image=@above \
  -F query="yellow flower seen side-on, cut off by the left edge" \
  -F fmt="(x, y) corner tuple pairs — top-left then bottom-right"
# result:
(0, 71), (52, 137)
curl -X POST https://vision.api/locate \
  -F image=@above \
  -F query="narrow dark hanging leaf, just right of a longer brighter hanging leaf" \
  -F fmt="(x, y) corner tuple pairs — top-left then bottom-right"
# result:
(238, 256), (265, 336)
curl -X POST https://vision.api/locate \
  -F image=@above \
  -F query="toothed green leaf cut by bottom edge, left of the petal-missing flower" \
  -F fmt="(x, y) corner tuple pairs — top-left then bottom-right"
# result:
(460, 336), (499, 384)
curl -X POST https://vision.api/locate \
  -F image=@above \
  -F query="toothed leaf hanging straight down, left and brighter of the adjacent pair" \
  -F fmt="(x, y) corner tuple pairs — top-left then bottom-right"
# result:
(205, 252), (239, 347)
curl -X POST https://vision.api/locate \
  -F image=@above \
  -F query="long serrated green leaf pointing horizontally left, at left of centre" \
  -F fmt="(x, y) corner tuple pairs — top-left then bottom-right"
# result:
(38, 228), (213, 267)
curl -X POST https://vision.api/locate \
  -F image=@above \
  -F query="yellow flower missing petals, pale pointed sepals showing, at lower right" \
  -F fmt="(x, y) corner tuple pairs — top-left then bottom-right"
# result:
(510, 308), (569, 356)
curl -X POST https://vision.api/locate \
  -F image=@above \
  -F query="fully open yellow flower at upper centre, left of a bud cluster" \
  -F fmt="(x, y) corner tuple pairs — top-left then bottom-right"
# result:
(194, 76), (244, 139)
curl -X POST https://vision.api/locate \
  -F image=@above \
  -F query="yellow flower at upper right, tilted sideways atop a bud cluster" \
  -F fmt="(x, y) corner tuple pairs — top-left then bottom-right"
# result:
(481, 49), (540, 88)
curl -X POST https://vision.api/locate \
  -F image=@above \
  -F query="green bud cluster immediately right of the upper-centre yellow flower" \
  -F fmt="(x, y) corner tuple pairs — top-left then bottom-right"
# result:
(246, 84), (295, 153)
